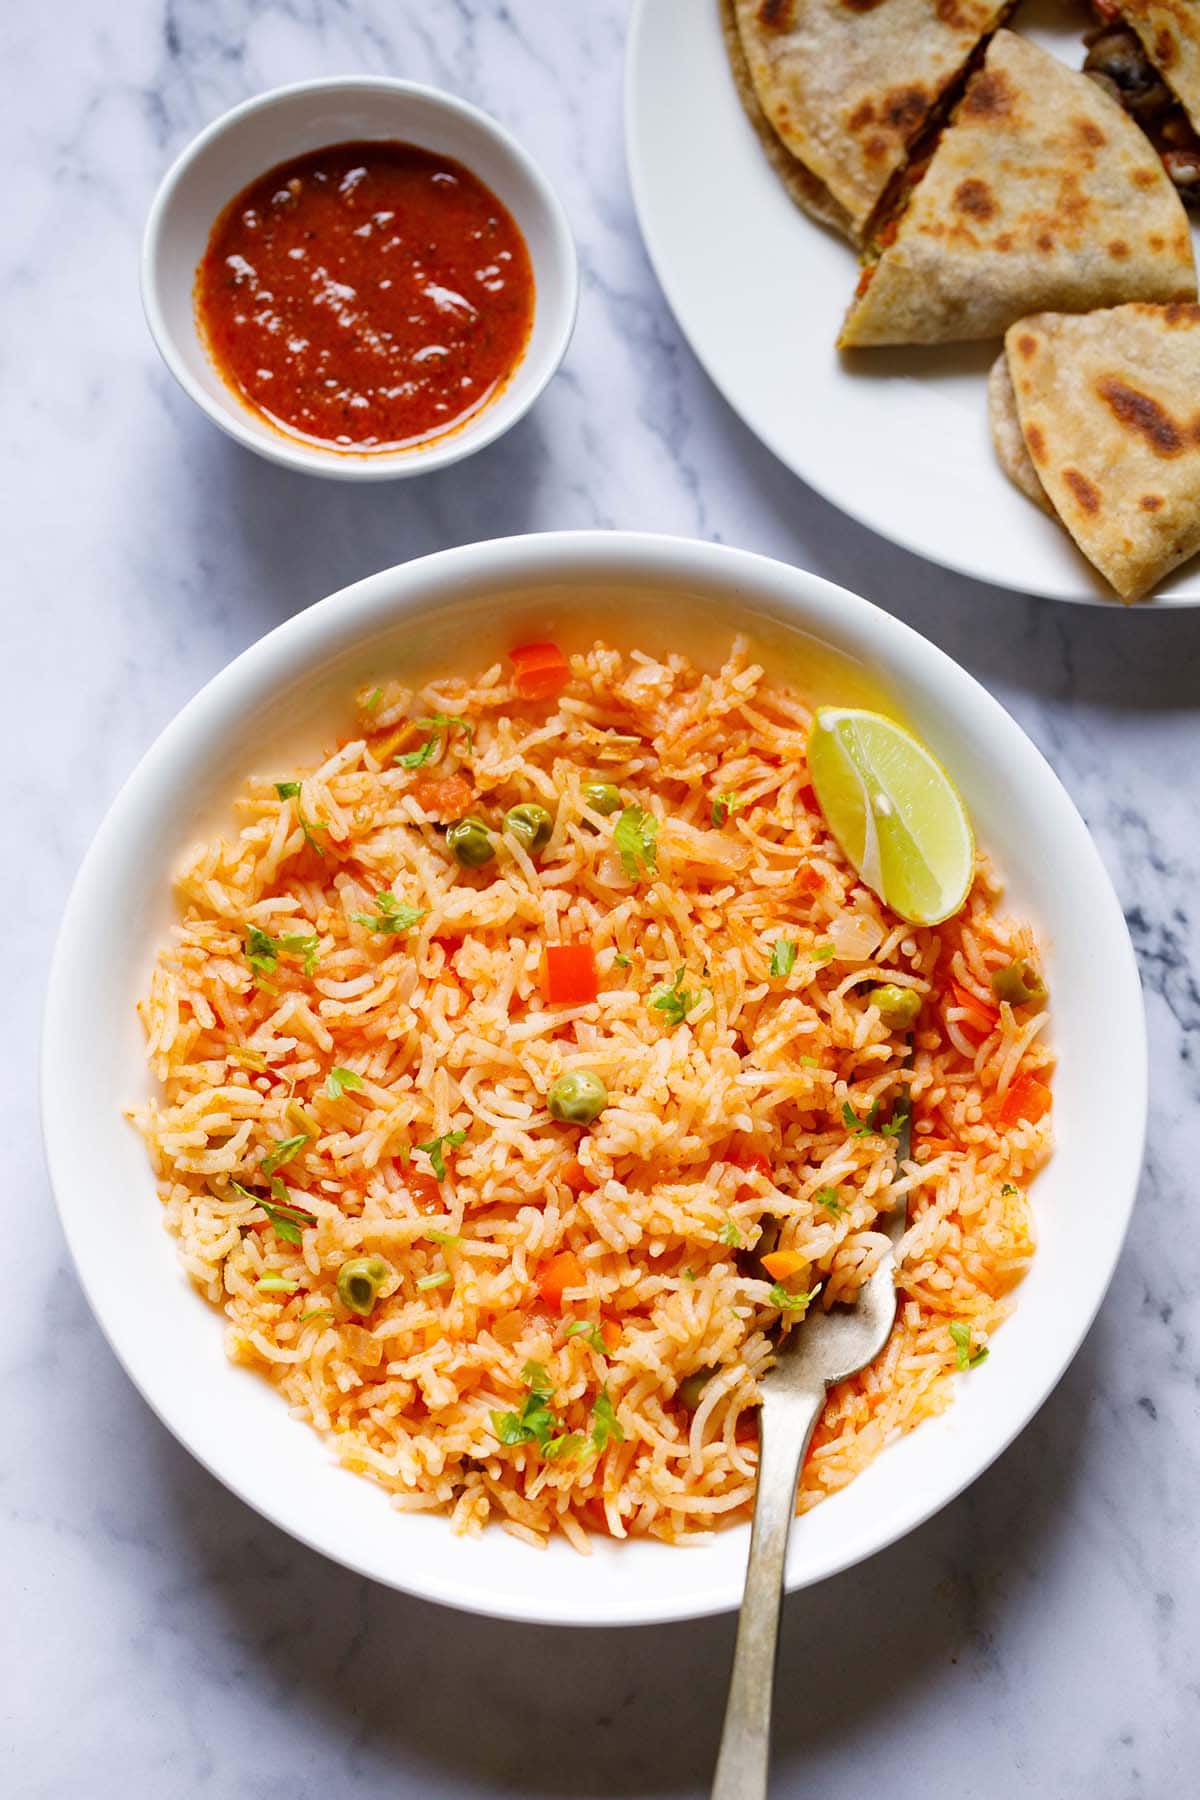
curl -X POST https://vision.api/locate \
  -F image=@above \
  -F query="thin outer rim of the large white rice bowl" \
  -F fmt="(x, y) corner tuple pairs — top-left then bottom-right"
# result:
(40, 531), (1148, 1625)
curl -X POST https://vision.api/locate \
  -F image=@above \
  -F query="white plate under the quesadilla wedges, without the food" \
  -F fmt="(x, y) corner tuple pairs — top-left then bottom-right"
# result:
(626, 0), (1200, 607)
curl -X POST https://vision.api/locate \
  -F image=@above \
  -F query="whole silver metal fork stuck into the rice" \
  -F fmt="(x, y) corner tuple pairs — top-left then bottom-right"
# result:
(712, 1094), (912, 1800)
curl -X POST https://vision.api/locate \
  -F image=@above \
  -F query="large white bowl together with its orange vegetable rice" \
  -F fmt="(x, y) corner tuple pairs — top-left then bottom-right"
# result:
(43, 533), (1146, 1625)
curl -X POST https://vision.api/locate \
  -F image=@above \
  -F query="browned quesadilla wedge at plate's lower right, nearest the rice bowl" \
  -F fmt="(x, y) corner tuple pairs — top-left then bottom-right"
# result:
(990, 301), (1200, 599)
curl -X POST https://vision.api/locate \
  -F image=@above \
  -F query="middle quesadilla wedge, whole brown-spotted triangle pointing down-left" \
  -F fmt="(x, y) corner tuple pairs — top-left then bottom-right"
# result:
(838, 31), (1196, 346)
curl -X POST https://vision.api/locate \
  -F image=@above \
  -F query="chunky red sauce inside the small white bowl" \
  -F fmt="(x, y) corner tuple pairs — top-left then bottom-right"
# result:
(196, 142), (534, 452)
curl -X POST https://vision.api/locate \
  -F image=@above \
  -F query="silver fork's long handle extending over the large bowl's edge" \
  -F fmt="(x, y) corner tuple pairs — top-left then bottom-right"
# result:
(712, 1382), (826, 1800)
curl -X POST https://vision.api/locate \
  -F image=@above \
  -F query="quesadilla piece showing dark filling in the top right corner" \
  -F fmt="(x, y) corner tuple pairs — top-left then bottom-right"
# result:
(1083, 0), (1200, 207)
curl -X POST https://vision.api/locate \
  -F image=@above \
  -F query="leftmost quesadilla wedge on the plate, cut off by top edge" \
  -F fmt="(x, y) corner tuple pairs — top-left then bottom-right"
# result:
(734, 0), (1013, 241)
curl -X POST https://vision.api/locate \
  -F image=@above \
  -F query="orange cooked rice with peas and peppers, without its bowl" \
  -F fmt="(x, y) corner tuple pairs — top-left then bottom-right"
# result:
(133, 639), (1051, 1550)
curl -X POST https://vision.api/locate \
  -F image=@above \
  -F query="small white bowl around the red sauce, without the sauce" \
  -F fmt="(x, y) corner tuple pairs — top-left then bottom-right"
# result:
(142, 76), (579, 481)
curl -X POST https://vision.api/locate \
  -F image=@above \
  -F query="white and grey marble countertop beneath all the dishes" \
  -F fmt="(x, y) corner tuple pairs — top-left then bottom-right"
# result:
(0, 0), (1200, 1800)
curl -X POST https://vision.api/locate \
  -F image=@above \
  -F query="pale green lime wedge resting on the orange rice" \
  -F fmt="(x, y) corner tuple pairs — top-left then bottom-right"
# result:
(808, 706), (975, 925)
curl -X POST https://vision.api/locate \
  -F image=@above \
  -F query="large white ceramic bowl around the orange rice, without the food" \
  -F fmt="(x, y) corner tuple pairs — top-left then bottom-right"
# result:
(43, 533), (1146, 1624)
